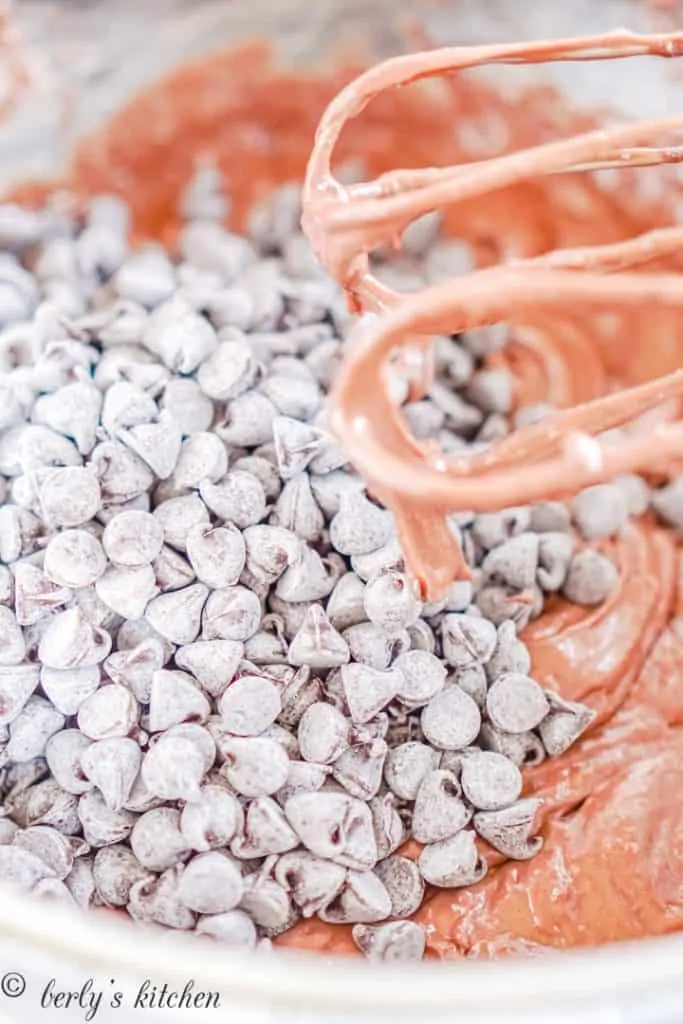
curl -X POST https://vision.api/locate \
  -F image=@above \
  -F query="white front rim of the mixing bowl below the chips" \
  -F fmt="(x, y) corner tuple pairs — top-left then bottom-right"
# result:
(0, 885), (683, 1019)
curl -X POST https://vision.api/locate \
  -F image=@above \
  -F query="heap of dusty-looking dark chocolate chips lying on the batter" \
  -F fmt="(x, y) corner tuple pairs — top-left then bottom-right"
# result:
(0, 166), (671, 959)
